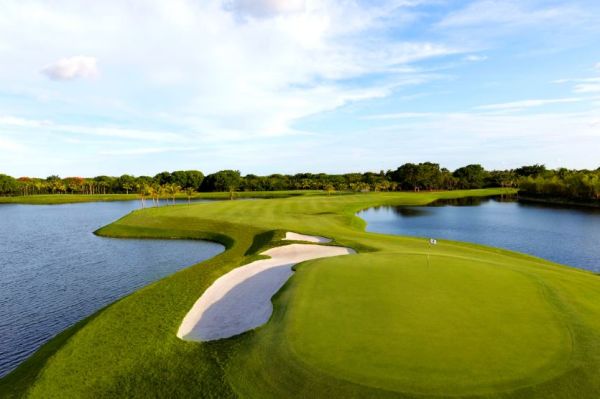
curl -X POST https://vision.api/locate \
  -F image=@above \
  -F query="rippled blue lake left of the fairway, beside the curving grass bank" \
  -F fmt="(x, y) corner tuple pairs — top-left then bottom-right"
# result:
(0, 201), (223, 376)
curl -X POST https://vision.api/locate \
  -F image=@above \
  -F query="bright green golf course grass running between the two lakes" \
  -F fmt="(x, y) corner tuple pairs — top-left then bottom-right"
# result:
(0, 188), (600, 399)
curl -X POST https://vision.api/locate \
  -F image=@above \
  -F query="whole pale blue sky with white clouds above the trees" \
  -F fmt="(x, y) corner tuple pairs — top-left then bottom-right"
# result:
(0, 0), (600, 177)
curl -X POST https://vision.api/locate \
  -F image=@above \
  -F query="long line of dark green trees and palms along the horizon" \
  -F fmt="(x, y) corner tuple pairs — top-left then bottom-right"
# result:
(0, 162), (600, 205)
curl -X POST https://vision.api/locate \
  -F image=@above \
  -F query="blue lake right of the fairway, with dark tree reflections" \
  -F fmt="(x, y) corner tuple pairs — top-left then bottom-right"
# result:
(358, 198), (600, 272)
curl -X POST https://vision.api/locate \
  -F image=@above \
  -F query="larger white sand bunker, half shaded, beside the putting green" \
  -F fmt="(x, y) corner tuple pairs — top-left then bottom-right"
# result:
(177, 234), (355, 341)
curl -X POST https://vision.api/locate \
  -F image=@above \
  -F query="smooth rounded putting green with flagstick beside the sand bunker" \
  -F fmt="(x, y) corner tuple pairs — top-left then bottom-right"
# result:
(282, 254), (571, 394)
